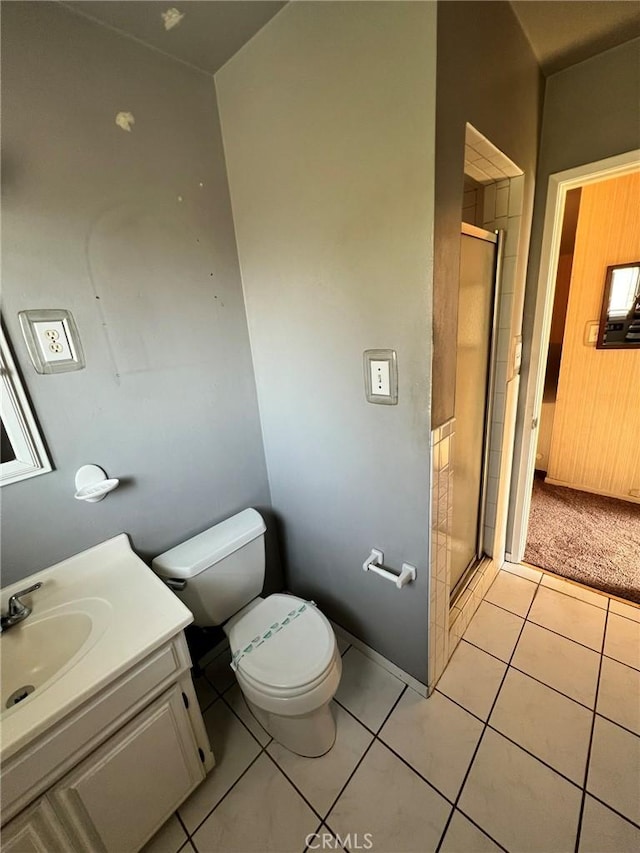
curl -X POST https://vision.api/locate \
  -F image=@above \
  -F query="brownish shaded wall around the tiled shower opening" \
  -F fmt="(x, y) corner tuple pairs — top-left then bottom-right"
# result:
(432, 2), (543, 427)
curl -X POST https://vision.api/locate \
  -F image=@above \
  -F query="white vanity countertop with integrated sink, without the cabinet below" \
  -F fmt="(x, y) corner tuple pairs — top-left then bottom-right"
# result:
(0, 534), (193, 761)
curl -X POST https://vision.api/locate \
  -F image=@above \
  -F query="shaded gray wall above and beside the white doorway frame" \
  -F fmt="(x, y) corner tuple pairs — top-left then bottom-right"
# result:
(507, 39), (640, 541)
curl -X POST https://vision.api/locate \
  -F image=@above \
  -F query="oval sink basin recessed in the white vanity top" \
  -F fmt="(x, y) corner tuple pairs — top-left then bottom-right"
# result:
(0, 599), (108, 716)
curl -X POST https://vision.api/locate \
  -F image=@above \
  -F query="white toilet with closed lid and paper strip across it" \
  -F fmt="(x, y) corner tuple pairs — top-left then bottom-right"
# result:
(151, 509), (342, 757)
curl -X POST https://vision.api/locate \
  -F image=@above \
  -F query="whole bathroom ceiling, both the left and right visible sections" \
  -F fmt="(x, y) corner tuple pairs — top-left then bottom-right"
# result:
(62, 0), (640, 75)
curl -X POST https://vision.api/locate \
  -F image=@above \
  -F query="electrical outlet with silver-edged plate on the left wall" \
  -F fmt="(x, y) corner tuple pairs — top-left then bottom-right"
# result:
(18, 308), (85, 373)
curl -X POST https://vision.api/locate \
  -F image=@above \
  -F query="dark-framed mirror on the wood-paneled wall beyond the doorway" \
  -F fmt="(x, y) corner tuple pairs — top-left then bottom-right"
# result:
(596, 261), (640, 349)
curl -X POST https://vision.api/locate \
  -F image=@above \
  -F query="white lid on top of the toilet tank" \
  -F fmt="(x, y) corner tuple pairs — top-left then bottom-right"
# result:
(151, 509), (266, 578)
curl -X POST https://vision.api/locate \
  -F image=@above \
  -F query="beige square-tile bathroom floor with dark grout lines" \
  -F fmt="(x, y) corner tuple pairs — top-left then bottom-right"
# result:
(145, 566), (640, 853)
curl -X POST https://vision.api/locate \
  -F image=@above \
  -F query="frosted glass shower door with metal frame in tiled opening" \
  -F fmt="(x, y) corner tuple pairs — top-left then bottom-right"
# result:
(451, 223), (498, 599)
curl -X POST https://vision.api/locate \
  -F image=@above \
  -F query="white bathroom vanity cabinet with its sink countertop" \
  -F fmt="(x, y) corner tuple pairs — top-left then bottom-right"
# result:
(0, 534), (214, 853)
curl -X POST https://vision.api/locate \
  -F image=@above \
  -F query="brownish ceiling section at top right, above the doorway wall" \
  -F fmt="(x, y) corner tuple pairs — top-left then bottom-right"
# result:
(510, 0), (640, 76)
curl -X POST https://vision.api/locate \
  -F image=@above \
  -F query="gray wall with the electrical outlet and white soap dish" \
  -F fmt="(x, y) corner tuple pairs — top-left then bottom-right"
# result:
(2, 3), (277, 585)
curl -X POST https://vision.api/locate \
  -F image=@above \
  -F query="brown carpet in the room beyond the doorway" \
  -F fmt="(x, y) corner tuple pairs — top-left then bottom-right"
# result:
(524, 475), (640, 604)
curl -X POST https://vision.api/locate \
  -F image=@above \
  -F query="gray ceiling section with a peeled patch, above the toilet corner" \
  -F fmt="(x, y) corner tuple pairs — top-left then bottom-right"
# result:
(63, 0), (285, 74)
